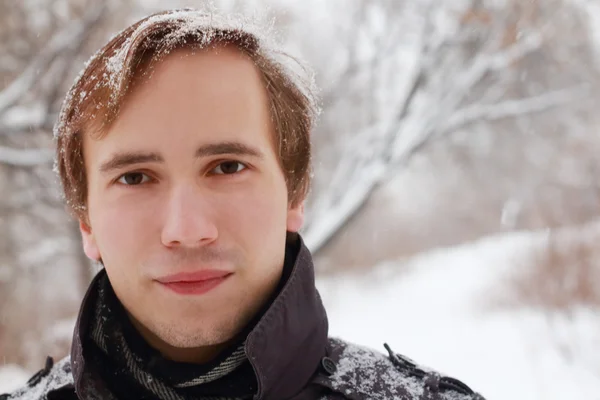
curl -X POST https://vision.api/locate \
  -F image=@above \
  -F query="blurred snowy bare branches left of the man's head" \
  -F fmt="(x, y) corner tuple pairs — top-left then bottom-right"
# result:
(0, 0), (114, 368)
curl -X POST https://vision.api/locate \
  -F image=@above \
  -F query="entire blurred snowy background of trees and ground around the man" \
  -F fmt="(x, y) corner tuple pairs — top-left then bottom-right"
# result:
(0, 0), (600, 400)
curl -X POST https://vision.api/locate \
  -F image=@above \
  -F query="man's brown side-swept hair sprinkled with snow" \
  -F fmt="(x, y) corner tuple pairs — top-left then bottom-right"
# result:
(54, 9), (318, 220)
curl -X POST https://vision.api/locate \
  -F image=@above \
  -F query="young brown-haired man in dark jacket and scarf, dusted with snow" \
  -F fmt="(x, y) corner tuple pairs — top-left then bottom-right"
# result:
(0, 10), (481, 400)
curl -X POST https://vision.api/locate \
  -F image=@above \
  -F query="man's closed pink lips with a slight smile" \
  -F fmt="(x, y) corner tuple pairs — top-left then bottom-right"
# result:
(156, 270), (233, 295)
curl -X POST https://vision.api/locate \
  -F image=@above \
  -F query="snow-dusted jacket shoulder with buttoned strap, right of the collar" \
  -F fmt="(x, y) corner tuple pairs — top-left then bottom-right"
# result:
(318, 338), (484, 400)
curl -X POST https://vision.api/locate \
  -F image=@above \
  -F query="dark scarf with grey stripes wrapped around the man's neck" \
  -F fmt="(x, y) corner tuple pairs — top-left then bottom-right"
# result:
(89, 276), (253, 400)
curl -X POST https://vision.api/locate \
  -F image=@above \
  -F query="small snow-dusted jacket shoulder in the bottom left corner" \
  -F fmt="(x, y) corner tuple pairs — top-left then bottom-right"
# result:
(0, 357), (73, 400)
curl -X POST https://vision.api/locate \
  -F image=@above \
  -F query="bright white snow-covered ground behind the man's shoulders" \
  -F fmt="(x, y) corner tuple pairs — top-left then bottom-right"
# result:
(0, 227), (600, 400)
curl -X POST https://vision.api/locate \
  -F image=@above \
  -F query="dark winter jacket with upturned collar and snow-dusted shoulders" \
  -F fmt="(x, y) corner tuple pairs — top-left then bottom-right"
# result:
(0, 239), (483, 400)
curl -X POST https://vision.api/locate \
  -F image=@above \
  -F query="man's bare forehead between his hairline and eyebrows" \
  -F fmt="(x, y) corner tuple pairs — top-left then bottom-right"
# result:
(85, 46), (272, 152)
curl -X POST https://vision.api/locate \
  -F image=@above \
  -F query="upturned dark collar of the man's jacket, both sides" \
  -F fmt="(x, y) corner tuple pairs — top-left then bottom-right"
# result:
(71, 235), (328, 400)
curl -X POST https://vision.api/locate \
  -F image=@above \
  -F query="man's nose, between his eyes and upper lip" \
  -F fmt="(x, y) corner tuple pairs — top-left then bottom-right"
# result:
(161, 185), (218, 247)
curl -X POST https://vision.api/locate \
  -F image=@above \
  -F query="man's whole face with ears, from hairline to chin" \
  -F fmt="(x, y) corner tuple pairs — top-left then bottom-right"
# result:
(80, 47), (303, 360)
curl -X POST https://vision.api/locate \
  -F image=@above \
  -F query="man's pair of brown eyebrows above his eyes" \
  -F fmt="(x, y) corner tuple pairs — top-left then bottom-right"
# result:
(100, 142), (264, 172)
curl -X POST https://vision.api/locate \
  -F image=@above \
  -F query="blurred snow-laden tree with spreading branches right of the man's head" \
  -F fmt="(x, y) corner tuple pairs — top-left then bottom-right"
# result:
(304, 0), (597, 252)
